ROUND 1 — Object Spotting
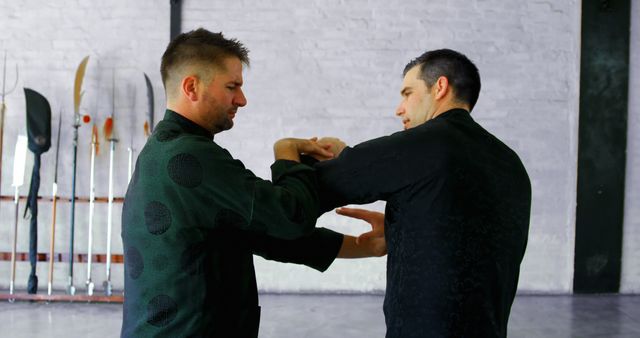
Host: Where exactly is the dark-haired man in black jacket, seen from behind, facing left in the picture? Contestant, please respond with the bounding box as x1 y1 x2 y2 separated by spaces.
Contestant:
315 49 531 338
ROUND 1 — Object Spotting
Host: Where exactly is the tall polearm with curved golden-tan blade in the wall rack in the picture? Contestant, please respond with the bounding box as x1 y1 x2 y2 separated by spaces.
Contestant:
67 56 89 295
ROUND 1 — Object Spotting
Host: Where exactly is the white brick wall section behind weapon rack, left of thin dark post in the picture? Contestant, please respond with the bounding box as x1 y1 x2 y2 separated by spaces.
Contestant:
0 0 169 292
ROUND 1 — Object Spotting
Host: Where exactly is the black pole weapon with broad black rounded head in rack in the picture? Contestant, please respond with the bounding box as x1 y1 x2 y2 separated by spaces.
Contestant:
24 88 51 294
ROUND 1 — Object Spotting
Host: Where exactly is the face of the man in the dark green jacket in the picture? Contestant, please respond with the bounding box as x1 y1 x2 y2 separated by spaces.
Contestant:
201 57 247 133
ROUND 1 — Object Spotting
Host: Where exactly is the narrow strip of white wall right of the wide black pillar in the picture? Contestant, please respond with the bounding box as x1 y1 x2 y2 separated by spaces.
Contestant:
620 0 640 293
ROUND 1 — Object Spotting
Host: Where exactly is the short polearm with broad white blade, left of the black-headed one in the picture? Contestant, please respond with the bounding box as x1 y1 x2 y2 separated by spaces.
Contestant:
9 135 28 295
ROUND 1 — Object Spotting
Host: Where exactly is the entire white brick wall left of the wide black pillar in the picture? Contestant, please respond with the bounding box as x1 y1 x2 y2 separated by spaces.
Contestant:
0 0 592 292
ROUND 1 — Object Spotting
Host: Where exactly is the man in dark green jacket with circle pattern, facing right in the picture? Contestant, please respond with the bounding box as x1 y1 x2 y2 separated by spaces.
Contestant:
121 29 386 337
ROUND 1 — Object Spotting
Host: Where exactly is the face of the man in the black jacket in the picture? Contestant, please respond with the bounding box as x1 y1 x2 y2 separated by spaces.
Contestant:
396 66 435 129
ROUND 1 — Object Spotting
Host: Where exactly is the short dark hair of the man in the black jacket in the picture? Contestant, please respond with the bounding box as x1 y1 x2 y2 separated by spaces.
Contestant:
402 49 480 110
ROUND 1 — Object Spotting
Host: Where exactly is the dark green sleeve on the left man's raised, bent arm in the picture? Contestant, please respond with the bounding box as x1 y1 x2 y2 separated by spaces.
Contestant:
178 137 318 239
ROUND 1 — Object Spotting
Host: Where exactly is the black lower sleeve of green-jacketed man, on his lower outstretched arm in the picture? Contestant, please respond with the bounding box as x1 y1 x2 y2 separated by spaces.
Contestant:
247 228 344 271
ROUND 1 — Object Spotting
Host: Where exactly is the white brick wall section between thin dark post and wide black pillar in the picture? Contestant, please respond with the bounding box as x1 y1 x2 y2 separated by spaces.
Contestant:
183 0 580 292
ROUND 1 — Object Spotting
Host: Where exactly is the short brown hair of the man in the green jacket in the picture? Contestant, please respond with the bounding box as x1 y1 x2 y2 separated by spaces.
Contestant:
160 28 249 95
